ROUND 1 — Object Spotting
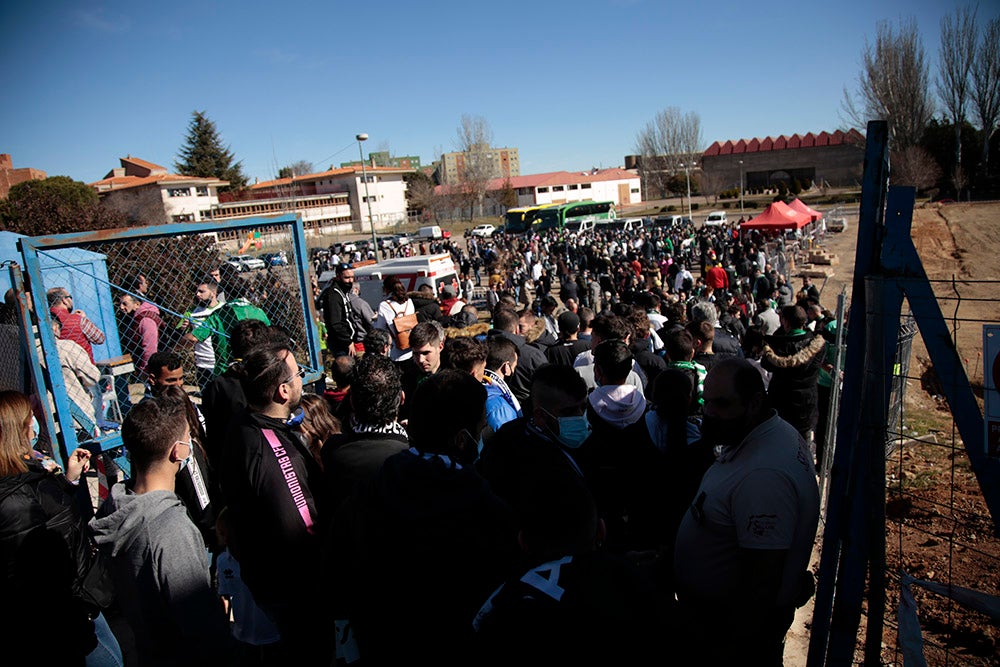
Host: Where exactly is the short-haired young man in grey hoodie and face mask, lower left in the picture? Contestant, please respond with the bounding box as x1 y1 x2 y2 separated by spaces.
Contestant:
90 398 232 665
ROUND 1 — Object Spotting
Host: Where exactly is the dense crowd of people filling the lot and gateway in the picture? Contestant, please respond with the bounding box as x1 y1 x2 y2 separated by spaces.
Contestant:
0 217 838 665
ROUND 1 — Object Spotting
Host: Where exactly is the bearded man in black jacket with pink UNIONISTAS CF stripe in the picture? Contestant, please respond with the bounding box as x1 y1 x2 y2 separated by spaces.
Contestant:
220 342 333 665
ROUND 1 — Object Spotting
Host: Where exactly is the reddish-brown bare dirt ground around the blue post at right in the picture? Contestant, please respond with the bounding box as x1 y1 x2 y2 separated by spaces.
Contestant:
786 203 1000 665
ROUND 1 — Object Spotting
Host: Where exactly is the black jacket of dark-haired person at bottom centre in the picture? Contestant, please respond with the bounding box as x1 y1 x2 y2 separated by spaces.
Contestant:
334 450 517 665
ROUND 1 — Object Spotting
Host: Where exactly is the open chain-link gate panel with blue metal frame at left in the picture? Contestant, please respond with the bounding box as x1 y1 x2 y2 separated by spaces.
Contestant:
14 216 322 468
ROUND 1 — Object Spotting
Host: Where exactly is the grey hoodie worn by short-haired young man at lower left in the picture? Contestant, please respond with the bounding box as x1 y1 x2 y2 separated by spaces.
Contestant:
90 483 230 665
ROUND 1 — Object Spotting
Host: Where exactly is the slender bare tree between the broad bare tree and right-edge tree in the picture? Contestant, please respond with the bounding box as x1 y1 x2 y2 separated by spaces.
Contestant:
937 7 976 170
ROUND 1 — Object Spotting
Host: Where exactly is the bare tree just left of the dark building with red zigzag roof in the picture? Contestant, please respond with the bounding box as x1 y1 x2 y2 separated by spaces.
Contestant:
635 107 702 199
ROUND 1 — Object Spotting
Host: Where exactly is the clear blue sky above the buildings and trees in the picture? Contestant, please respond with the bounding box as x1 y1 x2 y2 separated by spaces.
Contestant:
0 0 1000 182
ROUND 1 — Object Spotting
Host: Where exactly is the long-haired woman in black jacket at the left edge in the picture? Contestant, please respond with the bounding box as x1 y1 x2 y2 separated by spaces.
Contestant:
0 391 122 665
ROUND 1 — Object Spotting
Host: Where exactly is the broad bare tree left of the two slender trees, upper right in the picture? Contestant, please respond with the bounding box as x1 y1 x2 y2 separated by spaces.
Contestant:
843 18 934 150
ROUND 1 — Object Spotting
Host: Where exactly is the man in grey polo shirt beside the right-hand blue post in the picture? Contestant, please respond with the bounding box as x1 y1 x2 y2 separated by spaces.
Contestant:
674 358 819 665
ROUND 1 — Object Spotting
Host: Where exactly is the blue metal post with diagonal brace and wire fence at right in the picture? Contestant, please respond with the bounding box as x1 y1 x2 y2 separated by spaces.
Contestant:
809 121 1000 666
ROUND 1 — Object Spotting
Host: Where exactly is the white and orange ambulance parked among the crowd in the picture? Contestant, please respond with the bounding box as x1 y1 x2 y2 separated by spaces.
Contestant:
319 253 468 309
